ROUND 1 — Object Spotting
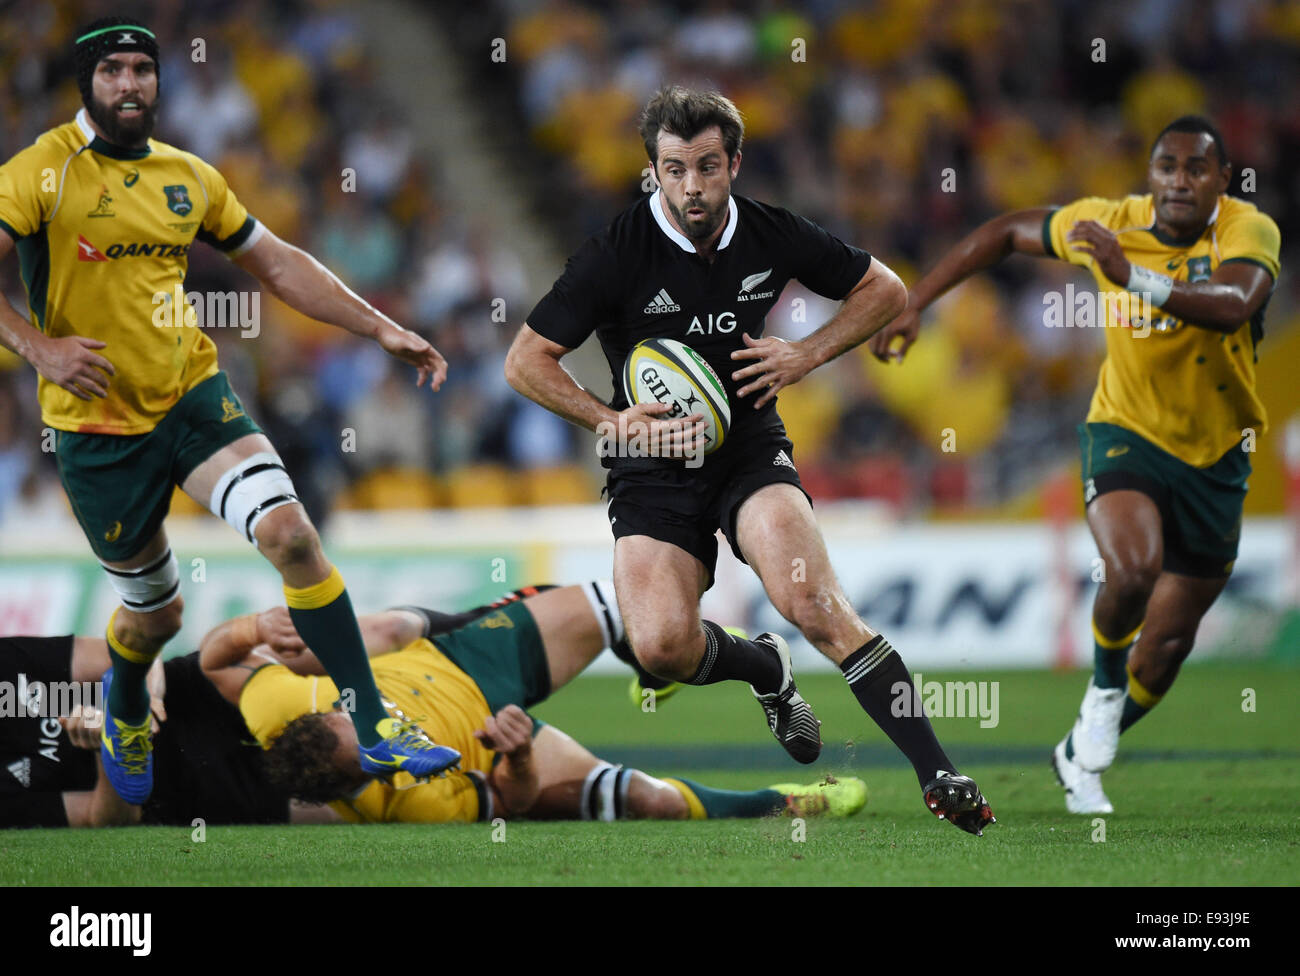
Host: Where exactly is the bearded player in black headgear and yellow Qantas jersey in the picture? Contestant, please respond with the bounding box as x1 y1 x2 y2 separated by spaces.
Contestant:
0 18 458 803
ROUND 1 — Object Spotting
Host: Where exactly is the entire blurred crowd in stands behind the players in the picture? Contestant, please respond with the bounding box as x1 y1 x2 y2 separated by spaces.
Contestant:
0 0 1300 535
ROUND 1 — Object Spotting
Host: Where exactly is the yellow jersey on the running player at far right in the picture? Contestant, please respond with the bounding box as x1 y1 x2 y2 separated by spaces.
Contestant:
1043 194 1282 468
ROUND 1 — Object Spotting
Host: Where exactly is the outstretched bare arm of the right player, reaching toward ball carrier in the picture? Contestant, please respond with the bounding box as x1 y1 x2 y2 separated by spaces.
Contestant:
868 207 1052 363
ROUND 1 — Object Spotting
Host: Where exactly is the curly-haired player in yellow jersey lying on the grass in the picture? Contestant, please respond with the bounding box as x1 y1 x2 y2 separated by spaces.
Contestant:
199 581 867 823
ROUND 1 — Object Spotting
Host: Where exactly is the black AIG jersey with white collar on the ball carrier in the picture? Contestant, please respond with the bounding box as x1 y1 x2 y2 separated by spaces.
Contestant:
527 191 871 462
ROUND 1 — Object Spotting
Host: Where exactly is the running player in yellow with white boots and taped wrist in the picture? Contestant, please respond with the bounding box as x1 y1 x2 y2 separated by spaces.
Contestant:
871 116 1281 814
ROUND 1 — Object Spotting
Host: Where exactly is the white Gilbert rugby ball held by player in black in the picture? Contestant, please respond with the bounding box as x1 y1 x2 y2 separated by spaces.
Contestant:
623 339 731 454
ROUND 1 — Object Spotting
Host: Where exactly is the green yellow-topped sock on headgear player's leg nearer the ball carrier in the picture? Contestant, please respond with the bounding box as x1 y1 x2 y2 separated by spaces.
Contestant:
285 569 389 746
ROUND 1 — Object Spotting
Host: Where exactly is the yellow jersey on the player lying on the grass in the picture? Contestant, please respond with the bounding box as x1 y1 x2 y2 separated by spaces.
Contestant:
239 638 495 824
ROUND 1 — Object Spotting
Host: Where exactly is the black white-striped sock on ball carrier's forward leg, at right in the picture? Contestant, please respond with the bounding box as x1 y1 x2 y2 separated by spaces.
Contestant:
840 634 957 786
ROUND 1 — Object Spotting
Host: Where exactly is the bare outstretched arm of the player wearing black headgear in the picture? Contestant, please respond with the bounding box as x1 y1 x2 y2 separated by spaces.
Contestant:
234 229 447 390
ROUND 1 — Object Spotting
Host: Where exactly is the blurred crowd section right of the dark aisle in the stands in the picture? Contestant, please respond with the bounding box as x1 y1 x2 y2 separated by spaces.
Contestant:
480 0 1300 509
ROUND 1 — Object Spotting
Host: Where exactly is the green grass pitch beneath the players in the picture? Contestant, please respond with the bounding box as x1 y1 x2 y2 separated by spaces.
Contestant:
0 664 1300 886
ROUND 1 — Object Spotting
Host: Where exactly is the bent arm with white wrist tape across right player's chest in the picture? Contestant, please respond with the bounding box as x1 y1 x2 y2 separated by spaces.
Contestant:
1066 221 1273 333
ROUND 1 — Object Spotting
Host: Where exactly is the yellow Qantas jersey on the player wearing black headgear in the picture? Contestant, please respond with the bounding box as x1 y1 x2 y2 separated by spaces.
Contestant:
0 109 261 434
